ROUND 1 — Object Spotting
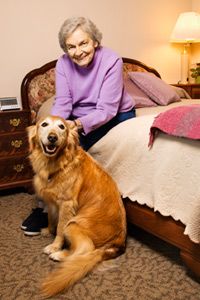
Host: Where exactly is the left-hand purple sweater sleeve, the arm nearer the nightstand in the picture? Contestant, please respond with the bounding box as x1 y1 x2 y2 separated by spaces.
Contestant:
51 60 72 119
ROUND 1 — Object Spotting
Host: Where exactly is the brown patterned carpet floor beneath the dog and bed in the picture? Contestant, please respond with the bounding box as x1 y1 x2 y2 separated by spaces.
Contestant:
0 192 200 300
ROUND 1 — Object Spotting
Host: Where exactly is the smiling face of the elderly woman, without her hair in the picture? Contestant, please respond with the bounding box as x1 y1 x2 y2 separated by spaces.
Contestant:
66 27 98 67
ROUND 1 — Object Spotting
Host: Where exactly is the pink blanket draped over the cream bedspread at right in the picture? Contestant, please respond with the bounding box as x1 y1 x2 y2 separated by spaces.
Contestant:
149 104 200 147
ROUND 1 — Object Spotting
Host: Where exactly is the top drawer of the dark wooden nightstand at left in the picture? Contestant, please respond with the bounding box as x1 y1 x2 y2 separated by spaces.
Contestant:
0 111 29 133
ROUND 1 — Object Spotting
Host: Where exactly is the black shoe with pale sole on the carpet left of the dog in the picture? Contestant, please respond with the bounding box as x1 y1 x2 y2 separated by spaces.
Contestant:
21 208 48 236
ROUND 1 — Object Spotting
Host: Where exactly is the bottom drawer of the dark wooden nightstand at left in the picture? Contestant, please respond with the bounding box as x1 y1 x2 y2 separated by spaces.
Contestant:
0 155 33 185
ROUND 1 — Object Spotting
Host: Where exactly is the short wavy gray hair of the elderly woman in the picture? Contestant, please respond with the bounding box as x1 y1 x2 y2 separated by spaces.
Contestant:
58 17 102 53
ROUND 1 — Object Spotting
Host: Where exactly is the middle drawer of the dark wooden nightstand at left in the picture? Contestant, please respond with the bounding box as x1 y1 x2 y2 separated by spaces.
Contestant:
0 132 28 157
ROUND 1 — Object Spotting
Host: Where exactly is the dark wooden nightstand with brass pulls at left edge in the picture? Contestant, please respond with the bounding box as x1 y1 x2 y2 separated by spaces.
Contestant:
0 109 33 190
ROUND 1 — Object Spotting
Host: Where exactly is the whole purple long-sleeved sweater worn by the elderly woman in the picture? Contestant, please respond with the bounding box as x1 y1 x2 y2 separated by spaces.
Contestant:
51 47 133 134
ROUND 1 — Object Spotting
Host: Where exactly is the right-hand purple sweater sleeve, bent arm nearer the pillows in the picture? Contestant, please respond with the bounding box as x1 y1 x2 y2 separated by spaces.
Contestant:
79 58 123 134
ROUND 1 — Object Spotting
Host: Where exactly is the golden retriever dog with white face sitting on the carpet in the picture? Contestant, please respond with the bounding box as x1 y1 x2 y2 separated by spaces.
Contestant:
27 116 126 297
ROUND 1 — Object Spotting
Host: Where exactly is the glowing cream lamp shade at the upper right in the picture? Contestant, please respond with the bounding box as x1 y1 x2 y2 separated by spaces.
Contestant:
170 12 200 43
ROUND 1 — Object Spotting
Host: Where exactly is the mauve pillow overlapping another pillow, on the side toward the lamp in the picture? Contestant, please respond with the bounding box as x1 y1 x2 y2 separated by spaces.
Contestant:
128 72 181 105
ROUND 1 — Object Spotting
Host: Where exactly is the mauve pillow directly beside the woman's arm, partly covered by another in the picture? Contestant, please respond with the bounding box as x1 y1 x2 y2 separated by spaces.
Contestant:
124 74 157 108
